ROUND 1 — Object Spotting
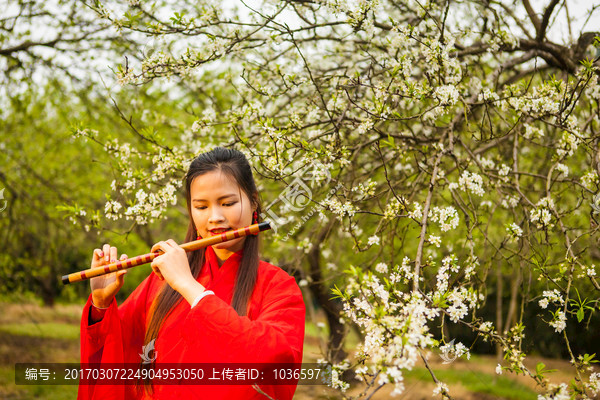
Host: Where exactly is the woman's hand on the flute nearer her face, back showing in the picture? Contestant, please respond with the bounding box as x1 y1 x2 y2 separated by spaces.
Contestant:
151 239 196 293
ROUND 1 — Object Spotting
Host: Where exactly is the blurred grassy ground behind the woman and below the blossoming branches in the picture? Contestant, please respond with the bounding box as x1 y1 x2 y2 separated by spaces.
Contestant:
0 303 592 400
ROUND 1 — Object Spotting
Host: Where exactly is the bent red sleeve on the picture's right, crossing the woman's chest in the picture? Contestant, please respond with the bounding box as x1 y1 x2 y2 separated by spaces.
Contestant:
183 270 305 399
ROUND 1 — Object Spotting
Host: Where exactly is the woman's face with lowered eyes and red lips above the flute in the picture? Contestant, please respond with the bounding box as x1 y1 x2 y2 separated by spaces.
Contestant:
190 170 255 260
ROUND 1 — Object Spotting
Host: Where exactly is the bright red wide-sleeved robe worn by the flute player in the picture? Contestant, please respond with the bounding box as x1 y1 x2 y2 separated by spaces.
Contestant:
77 247 305 400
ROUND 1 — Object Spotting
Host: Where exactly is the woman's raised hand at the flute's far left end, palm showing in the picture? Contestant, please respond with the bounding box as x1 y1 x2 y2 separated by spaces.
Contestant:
90 244 128 308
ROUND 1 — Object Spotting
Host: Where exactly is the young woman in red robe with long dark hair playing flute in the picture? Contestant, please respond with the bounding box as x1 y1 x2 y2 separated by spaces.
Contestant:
78 147 305 400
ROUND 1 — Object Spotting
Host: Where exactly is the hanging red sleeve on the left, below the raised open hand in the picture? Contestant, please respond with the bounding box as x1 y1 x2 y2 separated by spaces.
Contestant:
77 274 153 400
